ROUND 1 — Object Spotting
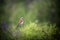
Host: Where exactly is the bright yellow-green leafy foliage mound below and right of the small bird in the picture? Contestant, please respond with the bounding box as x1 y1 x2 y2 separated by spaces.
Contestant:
20 22 56 40
